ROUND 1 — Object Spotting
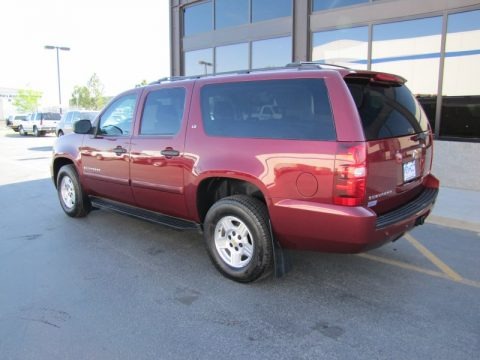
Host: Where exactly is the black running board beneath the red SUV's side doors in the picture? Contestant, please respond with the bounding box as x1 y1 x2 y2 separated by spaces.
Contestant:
90 196 202 232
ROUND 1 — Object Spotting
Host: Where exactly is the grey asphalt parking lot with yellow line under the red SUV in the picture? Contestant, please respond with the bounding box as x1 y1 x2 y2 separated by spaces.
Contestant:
0 124 480 360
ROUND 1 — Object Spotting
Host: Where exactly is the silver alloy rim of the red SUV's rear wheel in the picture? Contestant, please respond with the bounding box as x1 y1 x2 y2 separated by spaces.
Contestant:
215 216 255 269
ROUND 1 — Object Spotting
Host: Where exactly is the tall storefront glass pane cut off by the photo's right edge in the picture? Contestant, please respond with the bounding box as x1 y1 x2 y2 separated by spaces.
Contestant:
440 10 480 139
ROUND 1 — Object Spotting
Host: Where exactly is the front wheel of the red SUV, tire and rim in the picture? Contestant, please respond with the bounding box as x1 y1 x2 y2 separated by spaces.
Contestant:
57 165 91 217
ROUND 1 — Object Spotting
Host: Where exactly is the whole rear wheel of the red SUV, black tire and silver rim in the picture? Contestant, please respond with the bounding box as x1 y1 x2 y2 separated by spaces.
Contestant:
204 195 273 283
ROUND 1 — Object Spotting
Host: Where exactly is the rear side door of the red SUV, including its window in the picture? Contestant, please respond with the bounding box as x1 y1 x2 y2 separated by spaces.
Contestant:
130 87 190 217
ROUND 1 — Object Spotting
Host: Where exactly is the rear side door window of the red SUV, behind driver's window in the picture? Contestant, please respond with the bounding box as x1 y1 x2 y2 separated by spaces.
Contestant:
140 88 185 135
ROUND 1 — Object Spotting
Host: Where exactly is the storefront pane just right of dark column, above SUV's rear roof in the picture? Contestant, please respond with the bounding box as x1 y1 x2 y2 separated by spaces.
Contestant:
312 26 368 69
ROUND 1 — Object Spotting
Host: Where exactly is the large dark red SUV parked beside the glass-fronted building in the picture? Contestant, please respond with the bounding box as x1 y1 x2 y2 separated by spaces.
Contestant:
52 64 439 282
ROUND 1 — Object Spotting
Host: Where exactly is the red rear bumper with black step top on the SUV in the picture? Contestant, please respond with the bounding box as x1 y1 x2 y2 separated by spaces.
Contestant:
270 178 438 253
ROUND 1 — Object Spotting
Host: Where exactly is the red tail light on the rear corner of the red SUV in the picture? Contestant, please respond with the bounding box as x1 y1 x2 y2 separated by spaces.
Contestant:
333 143 367 206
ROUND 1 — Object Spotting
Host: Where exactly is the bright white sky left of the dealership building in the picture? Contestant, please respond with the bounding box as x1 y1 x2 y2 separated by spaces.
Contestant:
0 0 170 107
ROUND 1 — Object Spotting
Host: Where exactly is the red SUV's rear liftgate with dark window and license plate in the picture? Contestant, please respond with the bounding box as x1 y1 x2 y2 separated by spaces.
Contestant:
346 73 432 214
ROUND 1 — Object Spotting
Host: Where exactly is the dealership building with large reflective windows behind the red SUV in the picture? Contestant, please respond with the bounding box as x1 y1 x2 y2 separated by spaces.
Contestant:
170 0 480 190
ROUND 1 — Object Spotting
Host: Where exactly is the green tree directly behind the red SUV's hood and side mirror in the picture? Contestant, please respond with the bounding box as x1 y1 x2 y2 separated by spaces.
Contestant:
69 73 107 110
